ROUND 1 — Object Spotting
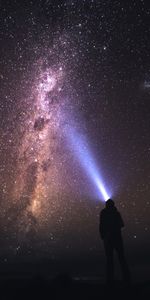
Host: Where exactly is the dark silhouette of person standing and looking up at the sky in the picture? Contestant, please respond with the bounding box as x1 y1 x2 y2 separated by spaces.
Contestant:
99 199 130 284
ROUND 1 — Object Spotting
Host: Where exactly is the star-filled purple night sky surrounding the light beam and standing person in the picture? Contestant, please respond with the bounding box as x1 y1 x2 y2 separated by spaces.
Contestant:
0 0 150 270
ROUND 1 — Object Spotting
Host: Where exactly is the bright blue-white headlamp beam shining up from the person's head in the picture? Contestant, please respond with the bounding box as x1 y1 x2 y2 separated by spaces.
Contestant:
67 127 110 201
